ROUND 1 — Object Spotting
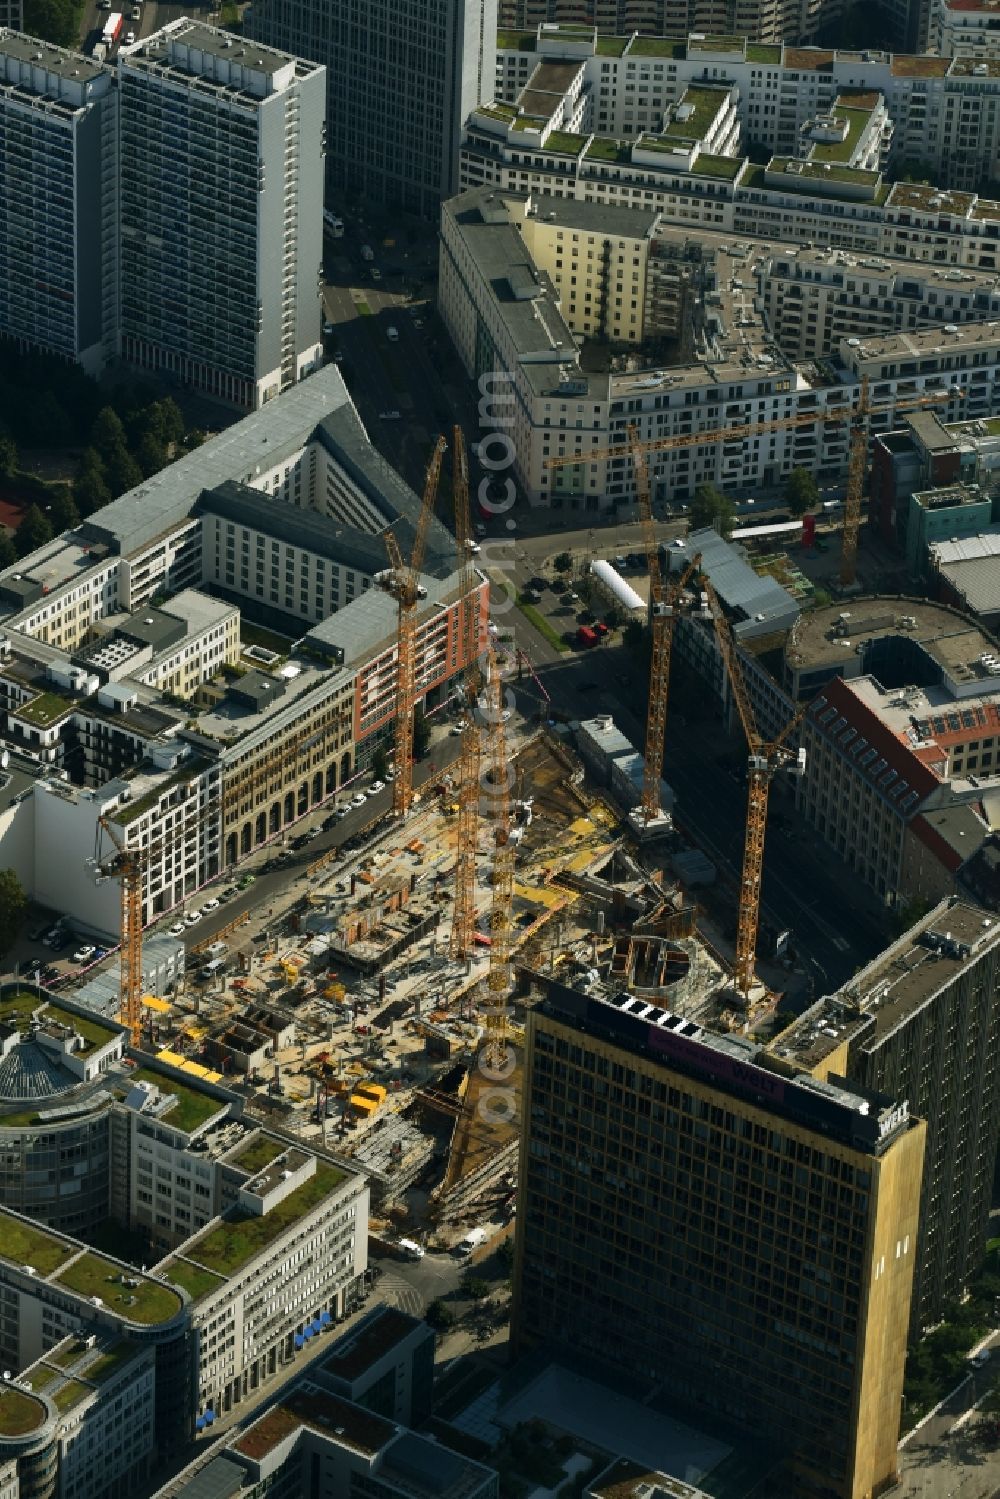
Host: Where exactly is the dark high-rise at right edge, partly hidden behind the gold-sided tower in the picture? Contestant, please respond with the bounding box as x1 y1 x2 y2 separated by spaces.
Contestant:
774 898 1000 1333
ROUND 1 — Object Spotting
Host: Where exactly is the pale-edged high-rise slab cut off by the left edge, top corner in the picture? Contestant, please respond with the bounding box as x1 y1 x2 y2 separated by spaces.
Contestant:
0 31 118 375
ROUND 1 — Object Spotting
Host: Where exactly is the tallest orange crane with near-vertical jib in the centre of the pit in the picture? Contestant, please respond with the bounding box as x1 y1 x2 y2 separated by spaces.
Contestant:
450 427 483 961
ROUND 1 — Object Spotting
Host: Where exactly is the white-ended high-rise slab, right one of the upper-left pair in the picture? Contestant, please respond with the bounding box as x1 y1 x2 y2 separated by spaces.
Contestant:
118 19 325 409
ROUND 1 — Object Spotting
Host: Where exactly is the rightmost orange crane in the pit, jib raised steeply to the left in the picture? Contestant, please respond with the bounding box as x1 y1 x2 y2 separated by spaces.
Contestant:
705 580 808 1009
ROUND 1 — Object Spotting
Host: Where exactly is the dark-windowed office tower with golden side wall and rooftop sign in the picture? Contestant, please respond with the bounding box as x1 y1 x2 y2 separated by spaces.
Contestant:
513 980 925 1499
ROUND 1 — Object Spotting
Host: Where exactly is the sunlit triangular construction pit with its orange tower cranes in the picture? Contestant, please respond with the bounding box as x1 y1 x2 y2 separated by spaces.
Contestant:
70 430 833 1249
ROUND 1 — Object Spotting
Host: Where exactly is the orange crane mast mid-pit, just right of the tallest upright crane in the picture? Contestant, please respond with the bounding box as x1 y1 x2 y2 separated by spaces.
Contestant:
483 646 516 1072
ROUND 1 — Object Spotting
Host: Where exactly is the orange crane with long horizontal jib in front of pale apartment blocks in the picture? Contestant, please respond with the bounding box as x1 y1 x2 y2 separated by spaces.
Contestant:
546 375 961 588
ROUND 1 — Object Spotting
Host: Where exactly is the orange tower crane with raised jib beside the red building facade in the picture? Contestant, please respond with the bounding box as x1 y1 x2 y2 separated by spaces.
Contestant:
375 438 447 817
